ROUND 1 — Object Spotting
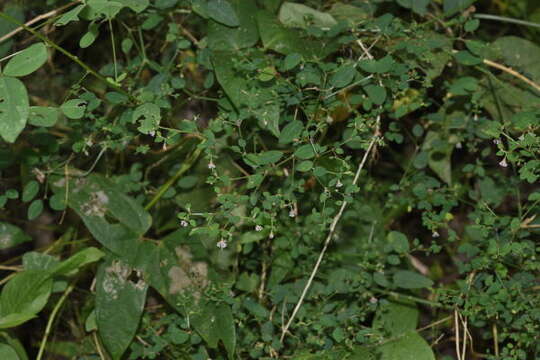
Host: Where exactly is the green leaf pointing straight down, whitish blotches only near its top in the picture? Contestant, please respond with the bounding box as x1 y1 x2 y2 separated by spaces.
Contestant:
95 257 148 360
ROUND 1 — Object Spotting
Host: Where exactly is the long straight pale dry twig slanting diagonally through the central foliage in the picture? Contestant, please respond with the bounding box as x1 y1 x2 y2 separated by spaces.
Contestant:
280 119 381 342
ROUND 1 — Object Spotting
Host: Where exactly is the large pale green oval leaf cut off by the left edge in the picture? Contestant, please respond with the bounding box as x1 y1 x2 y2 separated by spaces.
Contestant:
0 76 30 143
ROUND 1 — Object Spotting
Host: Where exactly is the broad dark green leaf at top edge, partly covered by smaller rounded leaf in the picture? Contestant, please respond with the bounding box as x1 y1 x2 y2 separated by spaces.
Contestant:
207 0 259 51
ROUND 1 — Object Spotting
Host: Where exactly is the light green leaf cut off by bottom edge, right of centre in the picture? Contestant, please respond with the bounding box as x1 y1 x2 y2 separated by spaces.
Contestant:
377 332 435 360
